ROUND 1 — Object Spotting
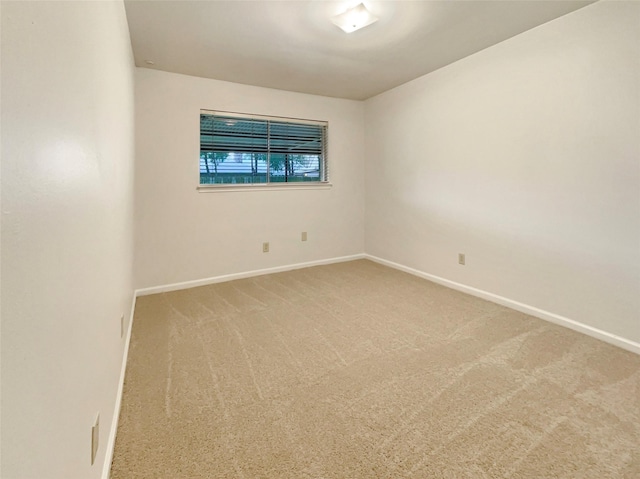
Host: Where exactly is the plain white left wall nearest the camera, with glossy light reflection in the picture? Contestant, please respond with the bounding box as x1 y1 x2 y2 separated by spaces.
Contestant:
1 2 134 479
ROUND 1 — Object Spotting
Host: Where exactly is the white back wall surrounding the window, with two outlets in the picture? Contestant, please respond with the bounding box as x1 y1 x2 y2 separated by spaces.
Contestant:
135 68 364 288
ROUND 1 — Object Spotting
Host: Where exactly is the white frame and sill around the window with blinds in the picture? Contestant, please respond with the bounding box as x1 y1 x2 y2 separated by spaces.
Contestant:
197 109 332 192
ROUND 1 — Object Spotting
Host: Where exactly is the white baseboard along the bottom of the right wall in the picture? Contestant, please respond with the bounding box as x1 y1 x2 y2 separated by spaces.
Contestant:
364 254 640 354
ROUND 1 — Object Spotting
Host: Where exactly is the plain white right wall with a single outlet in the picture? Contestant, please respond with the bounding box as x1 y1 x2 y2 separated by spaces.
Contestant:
365 2 640 342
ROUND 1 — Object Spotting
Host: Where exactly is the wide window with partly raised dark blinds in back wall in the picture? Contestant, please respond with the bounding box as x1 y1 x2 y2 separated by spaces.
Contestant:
200 110 328 186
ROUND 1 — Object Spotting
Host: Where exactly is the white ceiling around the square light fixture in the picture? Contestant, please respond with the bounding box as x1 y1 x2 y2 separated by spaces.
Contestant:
125 0 593 100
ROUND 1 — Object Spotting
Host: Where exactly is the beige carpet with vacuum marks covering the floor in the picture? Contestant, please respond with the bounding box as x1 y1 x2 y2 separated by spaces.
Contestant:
111 260 640 479
